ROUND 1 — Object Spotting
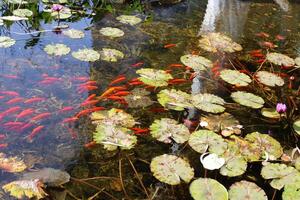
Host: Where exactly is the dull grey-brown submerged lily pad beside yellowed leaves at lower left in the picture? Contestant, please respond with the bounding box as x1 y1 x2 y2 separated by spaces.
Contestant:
22 168 70 187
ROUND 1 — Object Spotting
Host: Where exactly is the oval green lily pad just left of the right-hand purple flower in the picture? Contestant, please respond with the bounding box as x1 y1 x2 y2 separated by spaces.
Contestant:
231 91 265 109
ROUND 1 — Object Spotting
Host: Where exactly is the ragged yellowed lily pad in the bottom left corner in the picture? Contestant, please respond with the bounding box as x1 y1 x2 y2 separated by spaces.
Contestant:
2 179 47 199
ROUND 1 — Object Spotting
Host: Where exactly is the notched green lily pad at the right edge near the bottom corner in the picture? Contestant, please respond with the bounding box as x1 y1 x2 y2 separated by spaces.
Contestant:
261 163 300 190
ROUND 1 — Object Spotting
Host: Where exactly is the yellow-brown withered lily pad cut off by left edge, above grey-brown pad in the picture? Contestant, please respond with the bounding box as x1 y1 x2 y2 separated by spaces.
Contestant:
0 153 27 173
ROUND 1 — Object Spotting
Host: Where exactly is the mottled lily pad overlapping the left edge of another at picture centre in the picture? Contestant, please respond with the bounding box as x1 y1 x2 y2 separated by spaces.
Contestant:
157 89 194 111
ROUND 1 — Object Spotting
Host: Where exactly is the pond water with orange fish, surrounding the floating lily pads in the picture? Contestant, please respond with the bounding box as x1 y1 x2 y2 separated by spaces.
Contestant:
0 0 300 199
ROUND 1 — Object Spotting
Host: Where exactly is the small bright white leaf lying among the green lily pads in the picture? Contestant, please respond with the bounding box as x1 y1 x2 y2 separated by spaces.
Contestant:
200 153 225 170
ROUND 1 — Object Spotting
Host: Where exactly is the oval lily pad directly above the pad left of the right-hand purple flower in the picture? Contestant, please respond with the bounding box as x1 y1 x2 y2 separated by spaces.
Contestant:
256 71 284 87
